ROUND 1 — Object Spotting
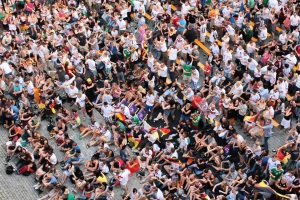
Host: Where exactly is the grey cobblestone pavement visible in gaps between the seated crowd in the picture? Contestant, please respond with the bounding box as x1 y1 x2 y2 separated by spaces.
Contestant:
0 41 286 200
